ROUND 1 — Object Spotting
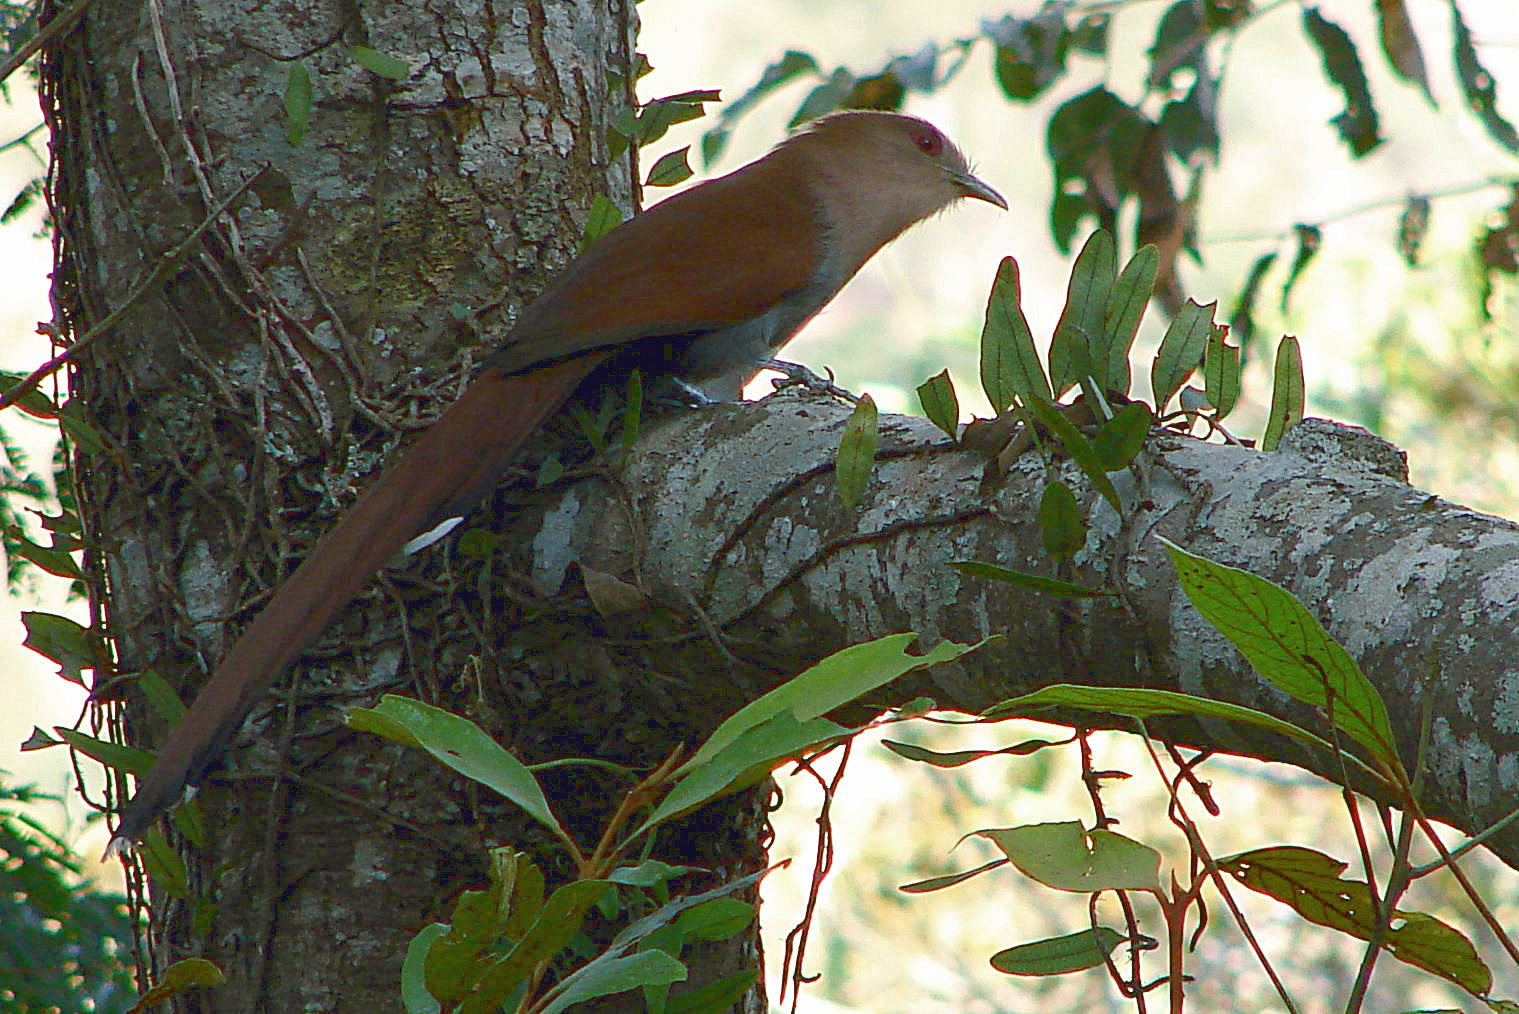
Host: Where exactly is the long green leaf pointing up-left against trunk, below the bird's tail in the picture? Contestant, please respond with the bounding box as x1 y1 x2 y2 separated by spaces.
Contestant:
343 694 568 839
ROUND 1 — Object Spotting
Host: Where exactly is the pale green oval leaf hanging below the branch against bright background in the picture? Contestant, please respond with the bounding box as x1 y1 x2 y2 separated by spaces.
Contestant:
974 820 1161 894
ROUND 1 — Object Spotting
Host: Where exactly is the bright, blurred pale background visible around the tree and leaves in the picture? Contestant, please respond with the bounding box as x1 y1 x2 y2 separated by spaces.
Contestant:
0 0 1519 1014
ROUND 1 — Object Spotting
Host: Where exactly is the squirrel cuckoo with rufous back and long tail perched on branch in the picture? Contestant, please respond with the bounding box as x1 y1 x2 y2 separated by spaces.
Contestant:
106 111 1007 856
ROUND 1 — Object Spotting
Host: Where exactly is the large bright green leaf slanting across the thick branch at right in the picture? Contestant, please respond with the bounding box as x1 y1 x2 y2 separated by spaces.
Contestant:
1162 539 1399 771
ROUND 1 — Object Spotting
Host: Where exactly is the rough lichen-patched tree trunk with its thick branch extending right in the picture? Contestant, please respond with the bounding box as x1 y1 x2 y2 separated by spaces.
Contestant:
43 0 1519 1012
